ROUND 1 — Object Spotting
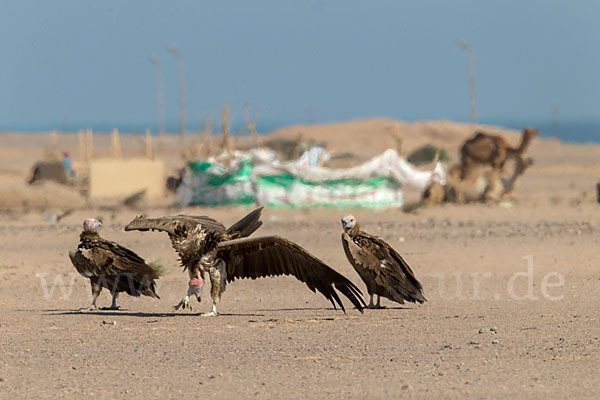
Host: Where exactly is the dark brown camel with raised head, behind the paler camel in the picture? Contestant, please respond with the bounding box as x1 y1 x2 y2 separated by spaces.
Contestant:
460 127 539 173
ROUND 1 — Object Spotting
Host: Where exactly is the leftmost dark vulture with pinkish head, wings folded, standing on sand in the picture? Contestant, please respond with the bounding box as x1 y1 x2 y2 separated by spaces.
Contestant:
69 218 159 310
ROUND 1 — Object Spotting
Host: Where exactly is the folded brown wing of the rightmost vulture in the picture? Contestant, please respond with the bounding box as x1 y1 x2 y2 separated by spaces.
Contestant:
344 231 427 303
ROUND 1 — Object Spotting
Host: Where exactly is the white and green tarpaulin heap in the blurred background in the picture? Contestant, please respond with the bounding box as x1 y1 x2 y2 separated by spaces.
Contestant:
178 149 445 207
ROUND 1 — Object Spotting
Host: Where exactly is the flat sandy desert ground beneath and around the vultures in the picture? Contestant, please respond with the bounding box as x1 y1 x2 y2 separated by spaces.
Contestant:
0 120 600 399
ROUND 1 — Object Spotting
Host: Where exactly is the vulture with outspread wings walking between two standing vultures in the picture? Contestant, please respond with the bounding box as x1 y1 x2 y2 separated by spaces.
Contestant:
125 208 365 316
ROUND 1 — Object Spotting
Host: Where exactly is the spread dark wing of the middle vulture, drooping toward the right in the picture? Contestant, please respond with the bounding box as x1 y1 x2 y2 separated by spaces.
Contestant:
217 236 365 312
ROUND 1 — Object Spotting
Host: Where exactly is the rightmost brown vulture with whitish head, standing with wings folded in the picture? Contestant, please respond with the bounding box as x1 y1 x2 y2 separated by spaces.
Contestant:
342 215 427 308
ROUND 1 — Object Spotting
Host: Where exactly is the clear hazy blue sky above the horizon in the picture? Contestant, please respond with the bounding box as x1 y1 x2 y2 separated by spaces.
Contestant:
0 0 600 130
